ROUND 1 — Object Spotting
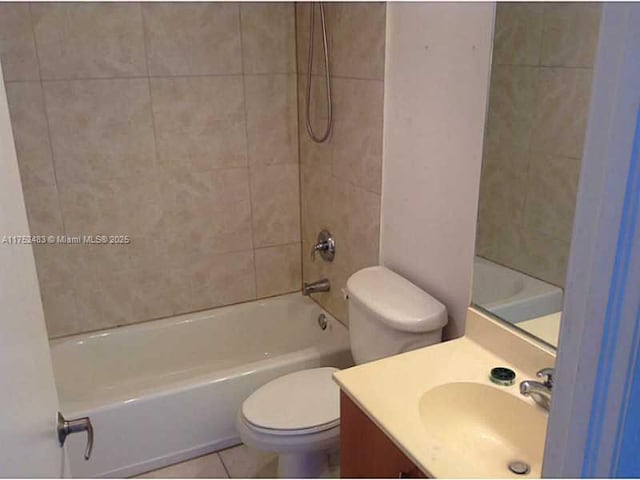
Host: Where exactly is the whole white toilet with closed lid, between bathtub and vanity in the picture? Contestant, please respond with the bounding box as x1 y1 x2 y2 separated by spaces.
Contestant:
236 266 447 478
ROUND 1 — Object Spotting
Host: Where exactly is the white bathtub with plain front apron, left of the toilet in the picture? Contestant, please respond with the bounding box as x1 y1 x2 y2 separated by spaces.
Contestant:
51 294 353 477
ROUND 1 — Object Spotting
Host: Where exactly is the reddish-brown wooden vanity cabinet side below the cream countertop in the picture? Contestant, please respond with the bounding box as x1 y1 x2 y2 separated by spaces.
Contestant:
340 391 427 478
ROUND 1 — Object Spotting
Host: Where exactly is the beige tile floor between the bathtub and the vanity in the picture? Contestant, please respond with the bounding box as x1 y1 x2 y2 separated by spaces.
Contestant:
137 445 340 478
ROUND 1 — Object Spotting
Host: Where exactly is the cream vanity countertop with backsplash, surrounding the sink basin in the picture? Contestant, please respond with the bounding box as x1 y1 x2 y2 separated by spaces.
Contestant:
334 312 555 478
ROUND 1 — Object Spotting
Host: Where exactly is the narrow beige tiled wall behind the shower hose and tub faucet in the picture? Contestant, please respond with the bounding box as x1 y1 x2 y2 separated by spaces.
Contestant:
296 2 386 322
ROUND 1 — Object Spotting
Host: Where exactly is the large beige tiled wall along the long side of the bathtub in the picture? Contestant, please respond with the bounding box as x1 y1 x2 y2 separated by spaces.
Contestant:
0 3 300 337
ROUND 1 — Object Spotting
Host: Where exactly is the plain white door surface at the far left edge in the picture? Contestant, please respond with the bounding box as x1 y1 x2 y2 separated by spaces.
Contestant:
0 62 65 477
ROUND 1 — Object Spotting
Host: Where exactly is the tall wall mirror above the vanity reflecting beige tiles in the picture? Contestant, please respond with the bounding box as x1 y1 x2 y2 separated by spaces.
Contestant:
472 3 600 346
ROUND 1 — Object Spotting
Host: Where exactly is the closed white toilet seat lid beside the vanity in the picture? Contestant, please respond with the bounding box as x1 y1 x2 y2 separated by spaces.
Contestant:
242 367 340 431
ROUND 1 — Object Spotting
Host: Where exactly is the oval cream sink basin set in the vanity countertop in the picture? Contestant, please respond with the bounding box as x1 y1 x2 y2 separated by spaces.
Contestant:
419 383 547 478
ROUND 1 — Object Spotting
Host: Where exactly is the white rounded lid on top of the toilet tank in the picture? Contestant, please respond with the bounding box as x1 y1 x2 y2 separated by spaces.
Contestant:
347 266 447 332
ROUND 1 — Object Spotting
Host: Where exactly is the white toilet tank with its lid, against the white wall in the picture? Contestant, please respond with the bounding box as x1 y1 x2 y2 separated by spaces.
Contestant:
347 266 447 364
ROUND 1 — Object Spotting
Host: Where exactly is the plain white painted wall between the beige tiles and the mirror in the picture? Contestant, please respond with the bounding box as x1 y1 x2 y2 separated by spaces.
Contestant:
380 3 495 338
